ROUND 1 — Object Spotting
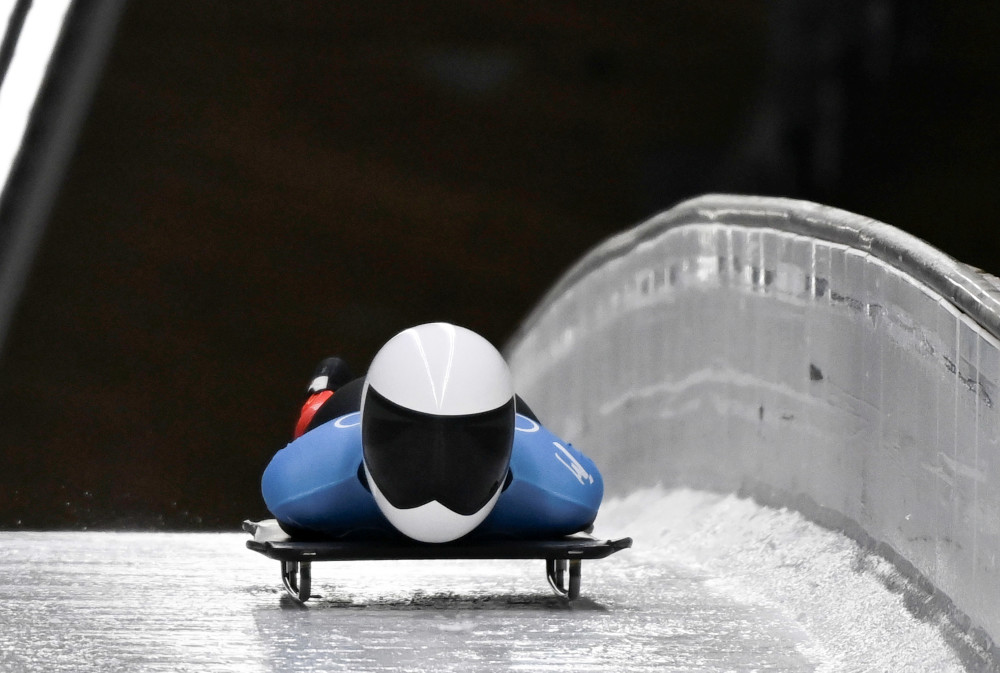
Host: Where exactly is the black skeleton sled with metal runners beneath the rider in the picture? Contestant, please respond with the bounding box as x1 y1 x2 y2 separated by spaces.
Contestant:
243 521 632 603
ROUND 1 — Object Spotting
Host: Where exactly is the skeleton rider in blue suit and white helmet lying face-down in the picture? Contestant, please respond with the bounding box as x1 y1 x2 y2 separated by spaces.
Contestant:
261 323 604 543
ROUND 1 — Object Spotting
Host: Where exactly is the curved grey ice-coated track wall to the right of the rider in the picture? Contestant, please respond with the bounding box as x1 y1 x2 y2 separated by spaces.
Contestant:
508 196 1000 649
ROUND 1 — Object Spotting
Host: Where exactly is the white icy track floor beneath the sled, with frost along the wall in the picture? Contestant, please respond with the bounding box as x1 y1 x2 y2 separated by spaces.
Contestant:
0 490 962 673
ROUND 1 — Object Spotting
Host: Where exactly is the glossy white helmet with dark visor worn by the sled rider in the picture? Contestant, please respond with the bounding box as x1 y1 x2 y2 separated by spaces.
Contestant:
361 323 514 542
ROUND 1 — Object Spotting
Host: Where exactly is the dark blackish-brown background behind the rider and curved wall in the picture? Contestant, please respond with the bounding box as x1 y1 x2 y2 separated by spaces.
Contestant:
0 0 1000 528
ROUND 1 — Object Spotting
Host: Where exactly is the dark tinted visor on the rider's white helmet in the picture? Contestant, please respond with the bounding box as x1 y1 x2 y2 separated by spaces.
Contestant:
361 386 514 516
